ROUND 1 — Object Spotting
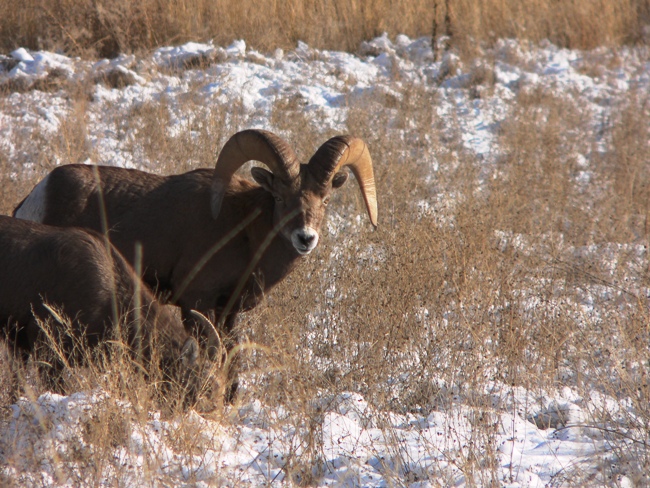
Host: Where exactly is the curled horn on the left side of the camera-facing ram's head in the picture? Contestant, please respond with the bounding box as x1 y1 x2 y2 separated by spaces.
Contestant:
210 129 300 219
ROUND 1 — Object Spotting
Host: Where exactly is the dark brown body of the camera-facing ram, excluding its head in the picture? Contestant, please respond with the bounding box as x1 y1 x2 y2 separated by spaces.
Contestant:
19 165 300 330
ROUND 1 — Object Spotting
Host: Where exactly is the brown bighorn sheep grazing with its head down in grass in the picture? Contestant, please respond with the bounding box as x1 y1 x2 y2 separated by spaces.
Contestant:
0 216 216 404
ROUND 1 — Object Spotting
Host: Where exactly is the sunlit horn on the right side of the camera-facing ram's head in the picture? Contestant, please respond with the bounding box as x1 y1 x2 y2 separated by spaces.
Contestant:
308 136 377 227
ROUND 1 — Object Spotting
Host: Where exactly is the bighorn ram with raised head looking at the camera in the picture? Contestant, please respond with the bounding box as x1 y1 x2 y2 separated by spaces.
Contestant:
14 129 377 391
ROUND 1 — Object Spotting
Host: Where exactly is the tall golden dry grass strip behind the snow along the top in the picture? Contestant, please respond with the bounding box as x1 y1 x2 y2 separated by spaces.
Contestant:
0 0 650 57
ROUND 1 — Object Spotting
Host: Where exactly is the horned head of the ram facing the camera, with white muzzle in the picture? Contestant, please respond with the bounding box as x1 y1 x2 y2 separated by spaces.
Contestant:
211 130 377 254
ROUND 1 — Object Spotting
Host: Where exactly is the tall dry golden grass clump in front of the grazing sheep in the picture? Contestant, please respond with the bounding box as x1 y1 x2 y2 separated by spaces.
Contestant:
0 307 223 416
